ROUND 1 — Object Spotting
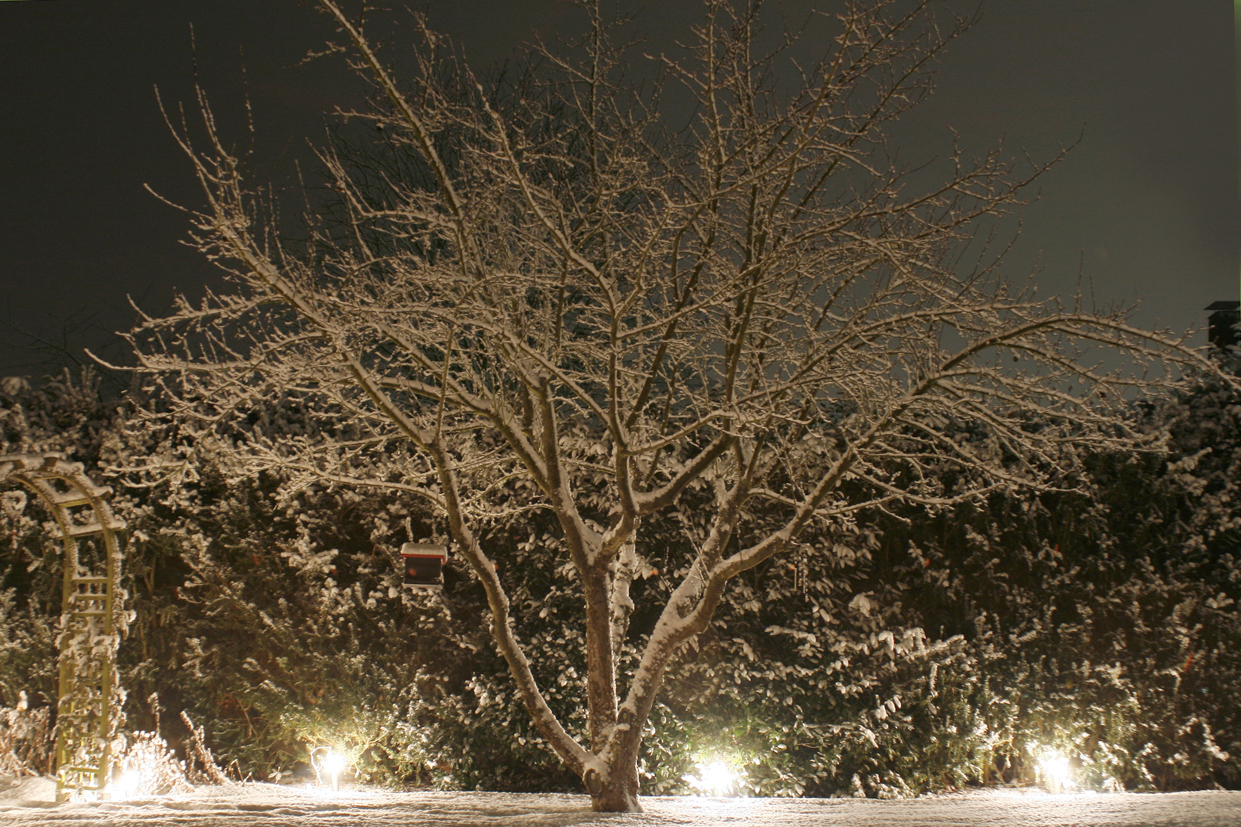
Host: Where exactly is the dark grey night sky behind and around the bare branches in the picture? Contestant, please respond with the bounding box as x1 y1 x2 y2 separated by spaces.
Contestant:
0 0 1241 375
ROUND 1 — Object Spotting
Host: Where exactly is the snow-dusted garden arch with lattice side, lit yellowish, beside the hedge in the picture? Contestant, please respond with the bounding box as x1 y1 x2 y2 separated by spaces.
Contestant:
0 454 127 801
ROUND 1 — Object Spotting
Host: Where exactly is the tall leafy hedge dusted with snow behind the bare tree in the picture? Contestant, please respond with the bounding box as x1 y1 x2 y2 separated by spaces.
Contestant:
0 367 1241 796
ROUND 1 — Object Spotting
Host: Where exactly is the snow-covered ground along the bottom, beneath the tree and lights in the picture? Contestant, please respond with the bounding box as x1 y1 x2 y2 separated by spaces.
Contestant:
0 777 1241 827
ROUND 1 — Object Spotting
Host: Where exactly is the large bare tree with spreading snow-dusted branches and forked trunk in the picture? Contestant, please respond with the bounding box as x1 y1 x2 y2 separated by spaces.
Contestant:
111 0 1226 811
